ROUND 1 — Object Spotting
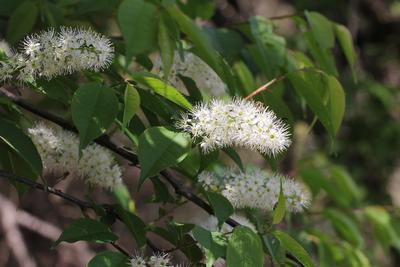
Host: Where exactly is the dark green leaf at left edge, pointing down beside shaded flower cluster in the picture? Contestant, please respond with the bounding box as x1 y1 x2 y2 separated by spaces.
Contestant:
0 118 43 176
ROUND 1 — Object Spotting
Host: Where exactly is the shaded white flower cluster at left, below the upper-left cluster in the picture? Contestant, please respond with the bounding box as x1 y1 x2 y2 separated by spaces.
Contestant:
28 123 122 190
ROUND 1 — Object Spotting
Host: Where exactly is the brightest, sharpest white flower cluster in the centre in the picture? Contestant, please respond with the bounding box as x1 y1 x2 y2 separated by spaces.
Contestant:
177 98 290 155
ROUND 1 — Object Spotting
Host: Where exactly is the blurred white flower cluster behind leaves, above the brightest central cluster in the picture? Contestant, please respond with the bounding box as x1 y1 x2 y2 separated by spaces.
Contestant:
153 51 226 96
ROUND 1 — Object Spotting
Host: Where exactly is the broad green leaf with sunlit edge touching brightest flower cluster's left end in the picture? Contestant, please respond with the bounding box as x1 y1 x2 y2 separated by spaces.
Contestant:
138 127 191 185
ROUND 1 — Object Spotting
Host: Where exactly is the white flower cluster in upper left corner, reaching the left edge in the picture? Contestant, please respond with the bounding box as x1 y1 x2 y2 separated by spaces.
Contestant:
0 27 114 82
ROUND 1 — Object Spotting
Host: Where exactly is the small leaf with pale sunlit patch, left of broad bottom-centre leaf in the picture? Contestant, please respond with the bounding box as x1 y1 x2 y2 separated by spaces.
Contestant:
192 225 226 259
